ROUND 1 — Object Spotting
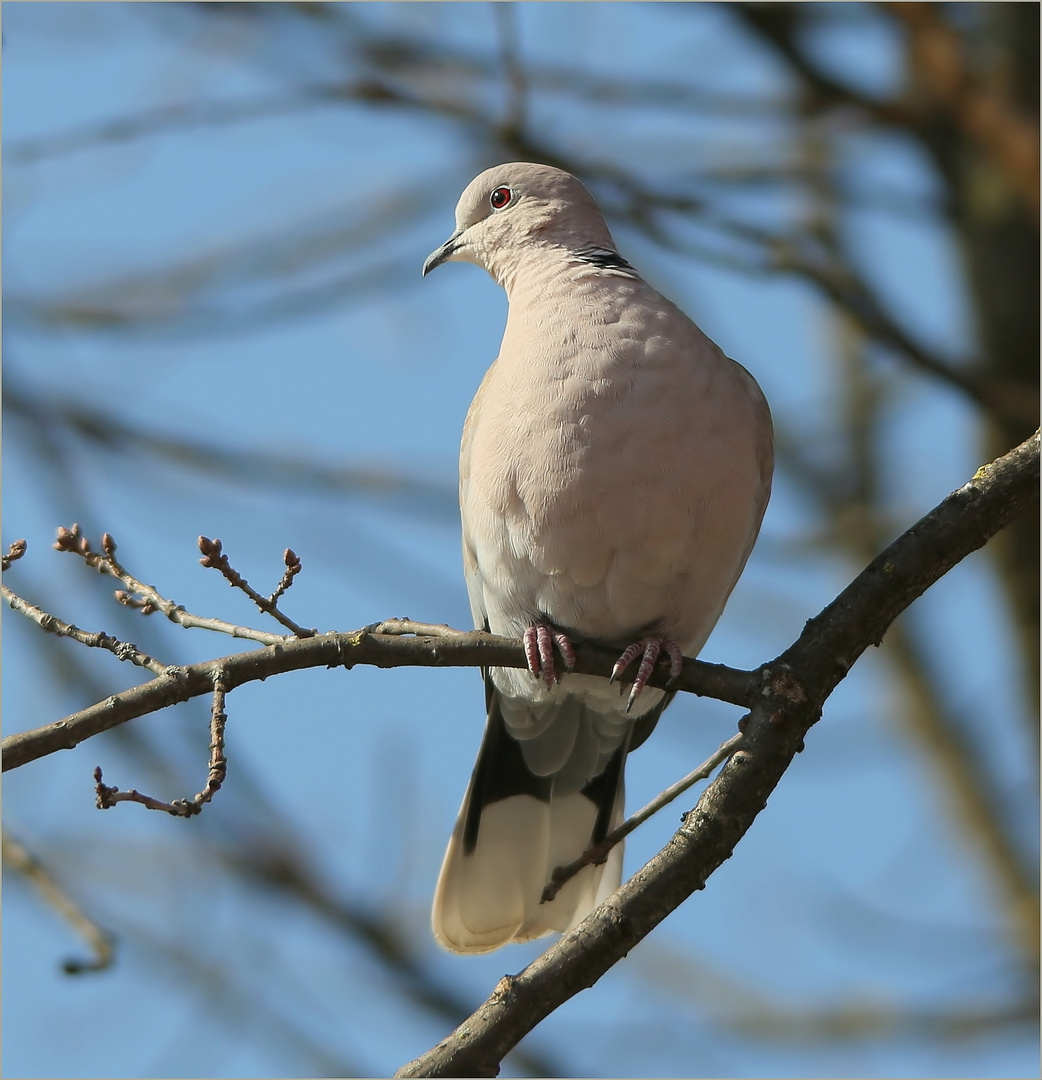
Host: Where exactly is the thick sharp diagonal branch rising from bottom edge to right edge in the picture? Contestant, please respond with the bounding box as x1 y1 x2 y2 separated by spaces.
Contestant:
396 432 1039 1077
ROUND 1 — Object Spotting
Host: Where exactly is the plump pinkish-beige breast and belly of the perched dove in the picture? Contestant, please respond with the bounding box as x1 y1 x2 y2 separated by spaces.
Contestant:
460 283 762 646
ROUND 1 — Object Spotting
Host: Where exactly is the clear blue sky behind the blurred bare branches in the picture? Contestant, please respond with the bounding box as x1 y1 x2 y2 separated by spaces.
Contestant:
3 3 1038 1077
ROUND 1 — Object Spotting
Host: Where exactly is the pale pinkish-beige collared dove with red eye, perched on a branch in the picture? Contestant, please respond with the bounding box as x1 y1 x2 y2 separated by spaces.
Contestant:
423 163 773 953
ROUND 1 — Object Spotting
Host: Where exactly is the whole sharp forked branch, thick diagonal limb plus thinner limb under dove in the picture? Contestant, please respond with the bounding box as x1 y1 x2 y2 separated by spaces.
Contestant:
2 432 1039 1076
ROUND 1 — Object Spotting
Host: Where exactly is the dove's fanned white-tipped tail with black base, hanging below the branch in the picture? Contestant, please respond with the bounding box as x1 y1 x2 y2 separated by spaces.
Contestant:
431 683 630 953
